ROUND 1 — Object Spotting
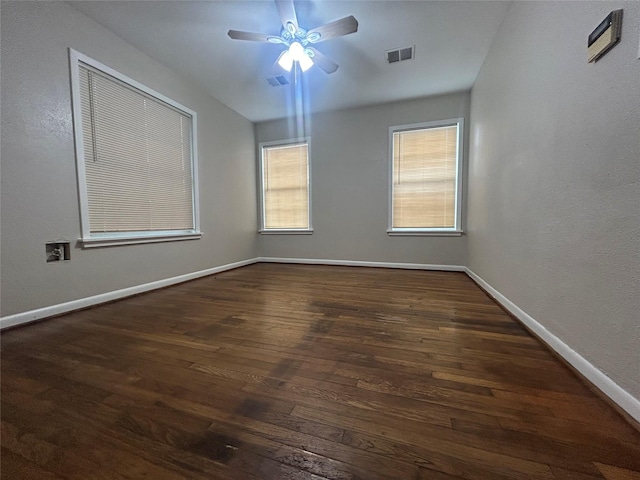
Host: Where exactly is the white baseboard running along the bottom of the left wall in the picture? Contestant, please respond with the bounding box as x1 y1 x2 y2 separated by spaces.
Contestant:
0 258 260 330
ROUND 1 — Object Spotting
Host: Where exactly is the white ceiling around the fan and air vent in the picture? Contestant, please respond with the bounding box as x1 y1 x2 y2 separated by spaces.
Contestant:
68 0 509 122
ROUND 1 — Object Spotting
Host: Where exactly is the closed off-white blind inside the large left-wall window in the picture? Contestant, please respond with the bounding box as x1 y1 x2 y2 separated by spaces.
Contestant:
79 64 195 234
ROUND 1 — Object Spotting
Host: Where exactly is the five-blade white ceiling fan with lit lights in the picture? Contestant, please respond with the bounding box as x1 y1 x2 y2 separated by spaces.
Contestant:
228 0 358 73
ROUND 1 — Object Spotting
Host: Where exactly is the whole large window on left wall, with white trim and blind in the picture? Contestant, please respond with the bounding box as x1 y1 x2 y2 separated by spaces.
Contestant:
70 50 201 247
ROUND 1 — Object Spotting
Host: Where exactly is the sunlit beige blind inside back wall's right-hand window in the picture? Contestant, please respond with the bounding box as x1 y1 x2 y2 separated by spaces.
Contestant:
392 125 458 228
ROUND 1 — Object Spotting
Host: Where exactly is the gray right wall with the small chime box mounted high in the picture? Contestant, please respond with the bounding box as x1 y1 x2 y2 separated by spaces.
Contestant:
468 2 640 398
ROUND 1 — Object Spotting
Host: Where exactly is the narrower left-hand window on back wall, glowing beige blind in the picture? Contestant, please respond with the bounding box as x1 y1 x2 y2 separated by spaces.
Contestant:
260 139 312 233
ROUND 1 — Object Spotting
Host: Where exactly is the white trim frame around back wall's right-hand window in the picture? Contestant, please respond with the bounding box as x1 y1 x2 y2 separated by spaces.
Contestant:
387 117 464 237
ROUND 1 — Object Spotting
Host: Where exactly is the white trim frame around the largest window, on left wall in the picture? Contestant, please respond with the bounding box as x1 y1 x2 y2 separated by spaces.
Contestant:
69 48 202 248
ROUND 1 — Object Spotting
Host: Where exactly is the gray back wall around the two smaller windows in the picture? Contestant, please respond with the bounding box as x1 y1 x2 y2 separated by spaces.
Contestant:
256 93 469 265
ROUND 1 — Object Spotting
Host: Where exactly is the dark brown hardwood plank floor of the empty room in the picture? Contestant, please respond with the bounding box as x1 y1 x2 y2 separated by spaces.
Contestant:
1 264 640 480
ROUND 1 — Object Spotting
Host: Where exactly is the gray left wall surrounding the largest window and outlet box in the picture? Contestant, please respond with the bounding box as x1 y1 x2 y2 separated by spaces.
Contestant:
1 2 257 316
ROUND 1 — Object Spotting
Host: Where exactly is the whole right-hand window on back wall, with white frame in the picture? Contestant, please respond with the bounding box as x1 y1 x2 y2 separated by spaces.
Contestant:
388 119 463 235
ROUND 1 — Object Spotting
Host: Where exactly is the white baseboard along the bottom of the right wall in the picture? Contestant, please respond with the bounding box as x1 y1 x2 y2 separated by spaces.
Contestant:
465 268 640 422
